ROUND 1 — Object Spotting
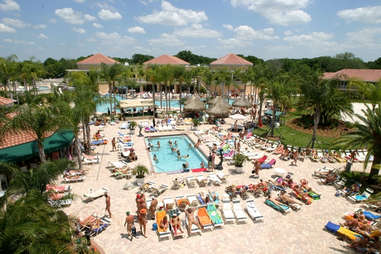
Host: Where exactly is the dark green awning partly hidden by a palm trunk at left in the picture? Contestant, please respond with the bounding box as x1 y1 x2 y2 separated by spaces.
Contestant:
0 131 74 162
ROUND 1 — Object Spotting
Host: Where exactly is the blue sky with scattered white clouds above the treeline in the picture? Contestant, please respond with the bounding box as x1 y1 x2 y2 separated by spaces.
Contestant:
0 0 381 61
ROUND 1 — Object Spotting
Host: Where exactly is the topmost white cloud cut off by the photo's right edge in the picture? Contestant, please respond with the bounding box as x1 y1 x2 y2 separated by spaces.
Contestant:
337 6 381 24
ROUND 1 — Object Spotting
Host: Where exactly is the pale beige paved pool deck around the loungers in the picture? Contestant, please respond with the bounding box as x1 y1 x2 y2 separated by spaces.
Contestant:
64 121 372 254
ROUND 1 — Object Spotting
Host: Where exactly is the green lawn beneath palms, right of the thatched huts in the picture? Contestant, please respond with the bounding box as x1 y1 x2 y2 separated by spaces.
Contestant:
254 113 336 149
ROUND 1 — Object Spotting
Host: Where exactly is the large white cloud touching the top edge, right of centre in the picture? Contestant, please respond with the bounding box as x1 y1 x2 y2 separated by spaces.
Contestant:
230 0 311 26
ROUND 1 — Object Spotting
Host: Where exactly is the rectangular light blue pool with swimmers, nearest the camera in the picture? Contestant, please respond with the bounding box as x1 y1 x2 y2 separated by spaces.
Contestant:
145 135 208 173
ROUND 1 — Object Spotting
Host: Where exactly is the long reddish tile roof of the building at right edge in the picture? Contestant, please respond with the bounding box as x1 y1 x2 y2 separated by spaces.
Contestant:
323 69 381 82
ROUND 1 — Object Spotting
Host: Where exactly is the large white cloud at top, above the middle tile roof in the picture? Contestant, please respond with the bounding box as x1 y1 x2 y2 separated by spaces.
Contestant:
138 0 208 26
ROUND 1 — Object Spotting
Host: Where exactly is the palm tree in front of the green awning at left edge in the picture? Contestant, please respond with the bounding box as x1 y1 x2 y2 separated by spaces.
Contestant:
0 104 62 162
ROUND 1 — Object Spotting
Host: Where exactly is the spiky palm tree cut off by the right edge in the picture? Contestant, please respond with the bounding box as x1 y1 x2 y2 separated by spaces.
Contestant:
338 103 381 181
